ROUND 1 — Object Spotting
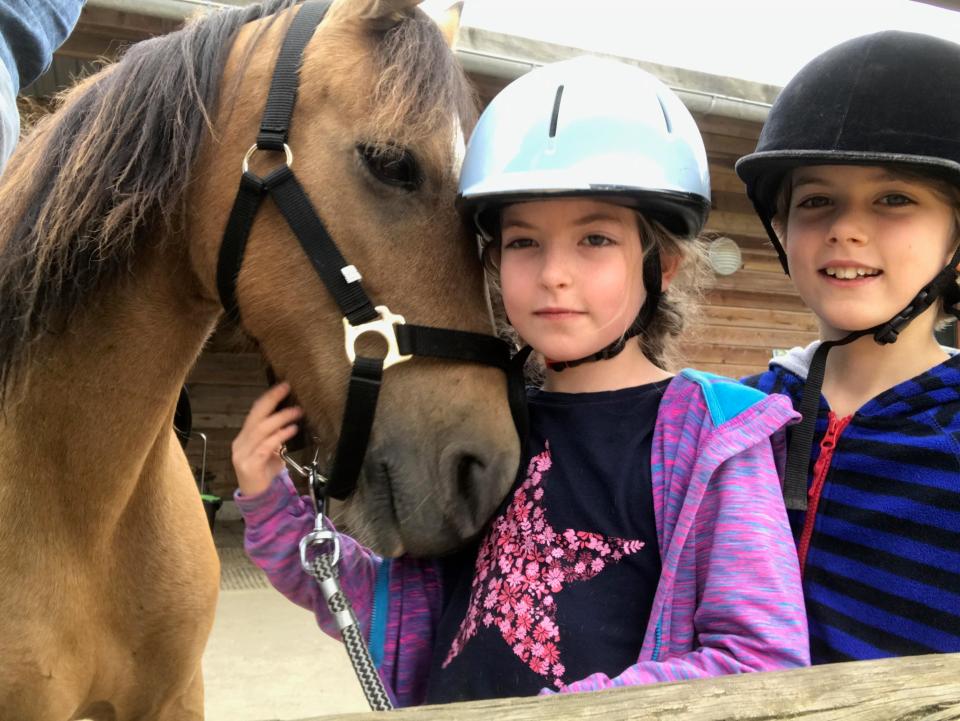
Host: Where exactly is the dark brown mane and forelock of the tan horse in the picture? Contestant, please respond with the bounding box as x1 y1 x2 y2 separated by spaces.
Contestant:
0 0 476 404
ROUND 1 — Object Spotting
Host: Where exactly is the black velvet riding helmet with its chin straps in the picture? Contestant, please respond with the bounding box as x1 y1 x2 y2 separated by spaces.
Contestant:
736 31 960 510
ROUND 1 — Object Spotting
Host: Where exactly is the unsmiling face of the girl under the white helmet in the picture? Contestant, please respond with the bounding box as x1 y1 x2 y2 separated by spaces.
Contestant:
500 198 646 361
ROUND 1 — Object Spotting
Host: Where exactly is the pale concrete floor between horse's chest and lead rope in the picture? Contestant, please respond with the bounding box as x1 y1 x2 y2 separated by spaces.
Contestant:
203 504 369 721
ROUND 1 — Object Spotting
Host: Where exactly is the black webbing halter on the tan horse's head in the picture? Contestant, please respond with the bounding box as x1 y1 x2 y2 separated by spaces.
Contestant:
217 1 526 499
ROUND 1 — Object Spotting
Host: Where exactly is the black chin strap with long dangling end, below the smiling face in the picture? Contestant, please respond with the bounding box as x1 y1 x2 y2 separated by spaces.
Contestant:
783 247 960 511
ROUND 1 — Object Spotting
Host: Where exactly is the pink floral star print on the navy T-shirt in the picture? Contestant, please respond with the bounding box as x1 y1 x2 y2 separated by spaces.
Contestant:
443 444 644 688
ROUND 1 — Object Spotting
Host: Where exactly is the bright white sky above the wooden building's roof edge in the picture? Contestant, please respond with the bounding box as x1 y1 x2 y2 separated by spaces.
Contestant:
421 0 960 85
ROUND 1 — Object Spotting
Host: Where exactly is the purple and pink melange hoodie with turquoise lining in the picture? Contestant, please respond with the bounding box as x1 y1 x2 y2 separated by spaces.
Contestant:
237 370 809 706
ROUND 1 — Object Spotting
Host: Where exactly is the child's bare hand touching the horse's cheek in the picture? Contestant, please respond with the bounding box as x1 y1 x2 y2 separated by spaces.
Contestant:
232 383 303 496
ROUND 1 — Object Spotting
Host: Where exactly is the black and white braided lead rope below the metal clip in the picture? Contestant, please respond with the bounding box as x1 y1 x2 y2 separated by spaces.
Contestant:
310 553 393 711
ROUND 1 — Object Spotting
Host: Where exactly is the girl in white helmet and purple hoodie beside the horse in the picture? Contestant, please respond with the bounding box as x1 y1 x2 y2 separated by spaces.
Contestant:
234 54 808 705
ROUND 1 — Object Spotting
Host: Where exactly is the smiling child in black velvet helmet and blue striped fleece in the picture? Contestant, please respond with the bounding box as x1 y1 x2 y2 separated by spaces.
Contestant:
737 31 960 663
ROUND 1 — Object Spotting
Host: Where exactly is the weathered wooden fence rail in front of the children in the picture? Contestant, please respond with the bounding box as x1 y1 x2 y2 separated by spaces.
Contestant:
305 654 960 721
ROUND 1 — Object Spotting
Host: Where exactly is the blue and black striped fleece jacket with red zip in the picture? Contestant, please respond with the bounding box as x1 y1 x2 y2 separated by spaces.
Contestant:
744 343 960 663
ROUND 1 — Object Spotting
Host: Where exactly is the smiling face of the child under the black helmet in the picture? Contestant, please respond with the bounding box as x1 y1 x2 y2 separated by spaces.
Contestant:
785 165 956 340
